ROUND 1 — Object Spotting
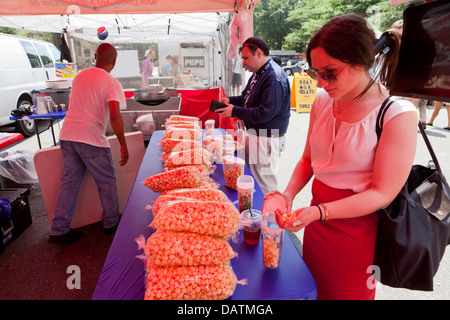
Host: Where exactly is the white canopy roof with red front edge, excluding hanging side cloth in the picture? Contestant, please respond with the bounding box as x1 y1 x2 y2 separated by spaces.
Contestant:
0 0 259 42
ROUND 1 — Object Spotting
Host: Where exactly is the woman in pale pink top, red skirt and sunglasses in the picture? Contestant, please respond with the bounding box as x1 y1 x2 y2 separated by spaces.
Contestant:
266 14 418 299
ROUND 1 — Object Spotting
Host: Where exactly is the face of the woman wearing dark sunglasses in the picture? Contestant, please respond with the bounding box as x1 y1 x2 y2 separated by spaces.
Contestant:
311 47 367 98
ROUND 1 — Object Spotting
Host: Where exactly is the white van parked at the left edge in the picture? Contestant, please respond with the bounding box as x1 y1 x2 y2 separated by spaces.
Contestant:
0 33 61 136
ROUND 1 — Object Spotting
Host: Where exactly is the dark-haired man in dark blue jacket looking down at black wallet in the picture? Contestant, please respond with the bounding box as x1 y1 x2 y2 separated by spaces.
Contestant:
216 37 291 193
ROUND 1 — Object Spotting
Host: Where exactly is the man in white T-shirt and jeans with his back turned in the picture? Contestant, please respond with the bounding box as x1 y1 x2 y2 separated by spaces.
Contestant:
49 43 128 243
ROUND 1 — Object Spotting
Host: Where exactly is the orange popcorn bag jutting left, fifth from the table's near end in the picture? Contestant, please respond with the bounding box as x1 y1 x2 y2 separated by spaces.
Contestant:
144 166 205 192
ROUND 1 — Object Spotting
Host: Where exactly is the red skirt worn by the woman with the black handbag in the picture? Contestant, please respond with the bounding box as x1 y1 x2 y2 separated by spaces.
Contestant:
303 179 378 300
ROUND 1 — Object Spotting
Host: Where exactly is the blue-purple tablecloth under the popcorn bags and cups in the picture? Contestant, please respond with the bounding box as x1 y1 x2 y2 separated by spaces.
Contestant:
92 131 317 300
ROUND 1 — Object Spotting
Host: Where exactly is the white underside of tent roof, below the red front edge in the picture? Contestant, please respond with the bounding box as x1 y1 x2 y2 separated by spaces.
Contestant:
0 13 230 43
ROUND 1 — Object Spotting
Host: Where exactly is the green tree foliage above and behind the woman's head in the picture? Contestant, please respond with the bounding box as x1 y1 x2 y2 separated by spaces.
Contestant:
254 0 418 52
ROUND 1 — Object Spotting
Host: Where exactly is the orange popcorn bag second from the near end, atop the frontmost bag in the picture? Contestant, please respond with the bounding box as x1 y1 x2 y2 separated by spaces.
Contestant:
144 230 236 266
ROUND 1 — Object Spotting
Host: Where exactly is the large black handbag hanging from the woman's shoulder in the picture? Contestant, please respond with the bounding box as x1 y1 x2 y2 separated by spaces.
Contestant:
374 98 450 291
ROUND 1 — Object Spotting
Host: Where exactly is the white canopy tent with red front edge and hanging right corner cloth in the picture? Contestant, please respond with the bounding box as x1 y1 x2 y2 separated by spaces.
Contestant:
0 0 260 90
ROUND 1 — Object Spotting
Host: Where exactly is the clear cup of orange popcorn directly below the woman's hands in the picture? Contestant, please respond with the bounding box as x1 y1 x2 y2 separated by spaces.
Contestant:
261 212 284 269
